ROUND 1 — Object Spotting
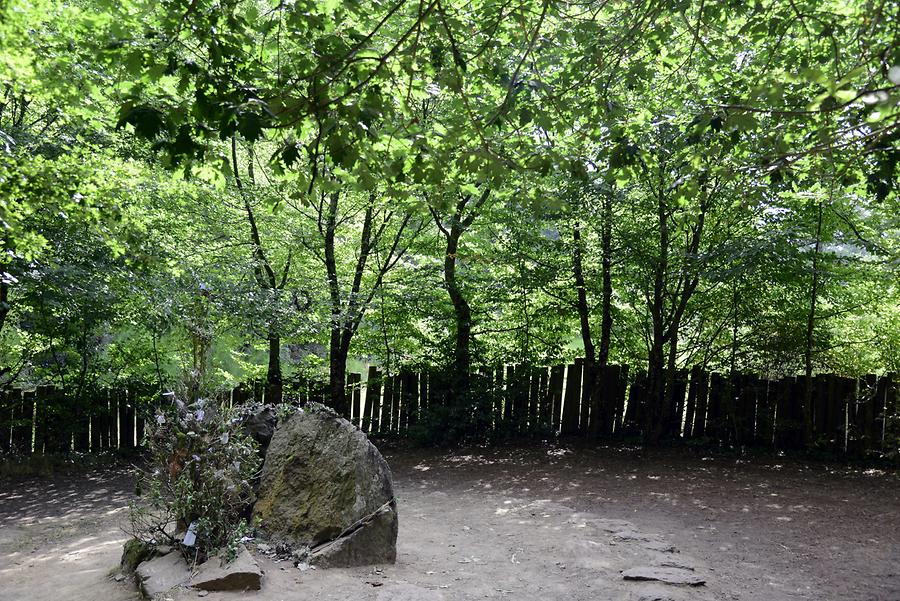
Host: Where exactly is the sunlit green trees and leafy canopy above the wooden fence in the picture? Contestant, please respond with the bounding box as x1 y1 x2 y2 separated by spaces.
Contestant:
0 0 900 439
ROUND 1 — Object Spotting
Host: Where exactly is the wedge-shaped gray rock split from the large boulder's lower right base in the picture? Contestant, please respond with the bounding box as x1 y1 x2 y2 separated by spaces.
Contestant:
309 505 397 568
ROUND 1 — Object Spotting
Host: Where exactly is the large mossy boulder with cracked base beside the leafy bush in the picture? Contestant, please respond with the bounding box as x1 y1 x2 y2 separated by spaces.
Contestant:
253 404 397 567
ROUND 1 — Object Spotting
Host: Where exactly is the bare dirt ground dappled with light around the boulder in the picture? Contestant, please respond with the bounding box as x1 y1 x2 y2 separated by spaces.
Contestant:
0 447 900 601
